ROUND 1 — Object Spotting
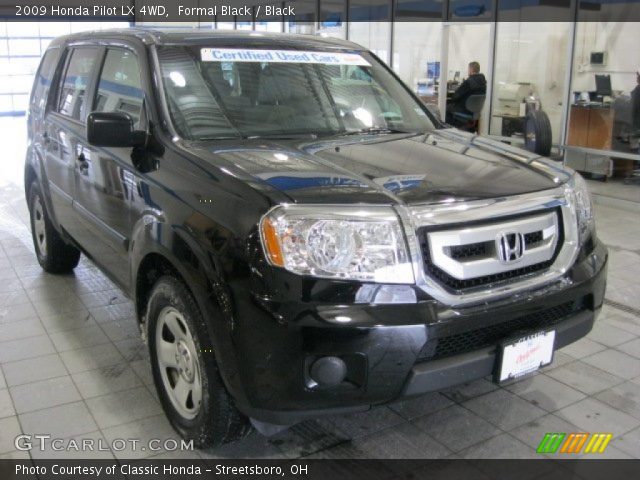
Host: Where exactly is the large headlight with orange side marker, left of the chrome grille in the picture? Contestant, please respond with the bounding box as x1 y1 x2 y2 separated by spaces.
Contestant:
260 205 414 283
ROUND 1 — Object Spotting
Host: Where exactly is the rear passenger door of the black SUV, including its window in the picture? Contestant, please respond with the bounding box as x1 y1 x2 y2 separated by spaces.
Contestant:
41 47 101 230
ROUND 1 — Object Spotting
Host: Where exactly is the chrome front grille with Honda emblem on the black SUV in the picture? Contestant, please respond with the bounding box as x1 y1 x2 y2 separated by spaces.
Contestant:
397 185 579 307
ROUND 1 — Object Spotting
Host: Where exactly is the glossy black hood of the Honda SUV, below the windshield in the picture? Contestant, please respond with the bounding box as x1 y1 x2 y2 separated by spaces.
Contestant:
190 129 570 204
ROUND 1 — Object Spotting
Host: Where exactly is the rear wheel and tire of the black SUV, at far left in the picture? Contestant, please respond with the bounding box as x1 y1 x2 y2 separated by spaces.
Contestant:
29 180 80 273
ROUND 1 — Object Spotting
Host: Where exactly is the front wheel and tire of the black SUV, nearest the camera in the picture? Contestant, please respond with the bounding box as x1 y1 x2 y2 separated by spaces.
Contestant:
147 275 250 448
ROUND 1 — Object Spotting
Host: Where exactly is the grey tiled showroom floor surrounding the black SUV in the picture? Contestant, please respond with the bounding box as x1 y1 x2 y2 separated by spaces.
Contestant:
0 119 640 459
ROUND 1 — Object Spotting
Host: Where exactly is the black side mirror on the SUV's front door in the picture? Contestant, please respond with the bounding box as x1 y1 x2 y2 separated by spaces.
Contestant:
87 112 147 148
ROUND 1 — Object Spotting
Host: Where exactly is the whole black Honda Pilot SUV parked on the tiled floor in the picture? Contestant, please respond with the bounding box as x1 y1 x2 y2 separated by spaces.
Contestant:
25 28 607 446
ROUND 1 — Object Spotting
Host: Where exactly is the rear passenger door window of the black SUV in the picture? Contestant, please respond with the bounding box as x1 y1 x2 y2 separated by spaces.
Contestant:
58 48 98 120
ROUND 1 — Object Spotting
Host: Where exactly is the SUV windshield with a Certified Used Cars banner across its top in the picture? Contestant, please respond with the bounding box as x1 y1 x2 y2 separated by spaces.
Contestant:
158 46 434 140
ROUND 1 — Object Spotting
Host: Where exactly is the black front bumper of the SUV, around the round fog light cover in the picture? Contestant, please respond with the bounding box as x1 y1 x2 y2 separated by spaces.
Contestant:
231 239 607 425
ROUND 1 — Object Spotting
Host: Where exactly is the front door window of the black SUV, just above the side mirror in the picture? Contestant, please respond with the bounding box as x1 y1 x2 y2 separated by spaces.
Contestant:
93 49 144 128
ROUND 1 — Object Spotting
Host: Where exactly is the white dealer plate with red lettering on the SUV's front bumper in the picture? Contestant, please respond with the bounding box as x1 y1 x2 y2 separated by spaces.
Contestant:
496 330 556 382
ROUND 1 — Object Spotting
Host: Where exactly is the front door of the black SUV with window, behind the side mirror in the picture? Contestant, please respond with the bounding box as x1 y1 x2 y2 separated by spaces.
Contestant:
74 47 146 287
